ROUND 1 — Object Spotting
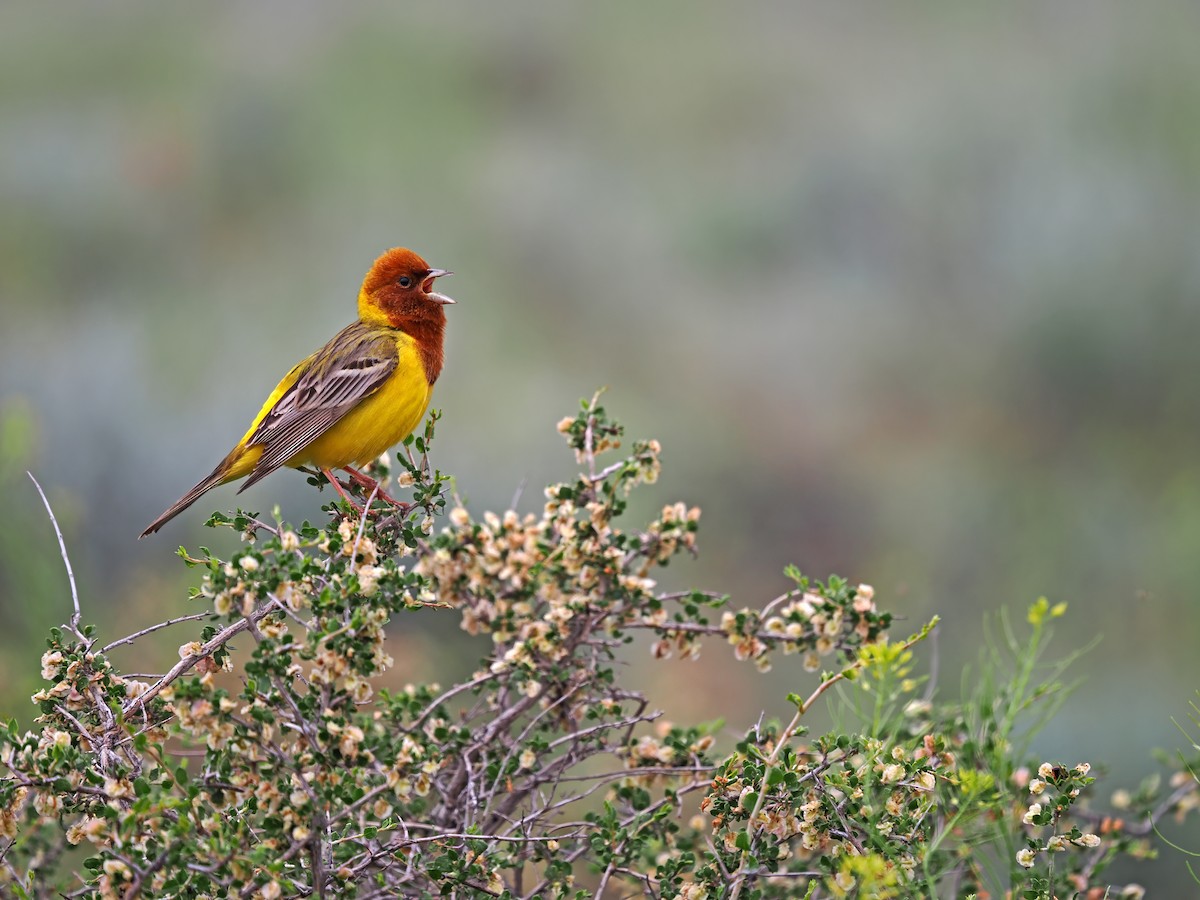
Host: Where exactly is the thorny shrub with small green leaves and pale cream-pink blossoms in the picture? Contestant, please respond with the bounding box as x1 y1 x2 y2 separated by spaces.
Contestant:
0 397 1196 900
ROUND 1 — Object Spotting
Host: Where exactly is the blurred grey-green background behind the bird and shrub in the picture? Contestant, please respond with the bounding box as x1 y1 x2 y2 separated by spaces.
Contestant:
0 0 1200 895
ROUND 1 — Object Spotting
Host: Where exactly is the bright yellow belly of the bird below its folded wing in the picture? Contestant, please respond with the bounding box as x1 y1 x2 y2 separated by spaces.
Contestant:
287 350 433 469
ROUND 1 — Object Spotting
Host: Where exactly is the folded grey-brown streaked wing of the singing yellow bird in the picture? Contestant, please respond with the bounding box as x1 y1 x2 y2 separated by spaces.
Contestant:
239 323 400 493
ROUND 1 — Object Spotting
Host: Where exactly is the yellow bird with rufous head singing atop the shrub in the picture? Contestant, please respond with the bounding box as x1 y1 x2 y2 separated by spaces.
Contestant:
139 247 455 540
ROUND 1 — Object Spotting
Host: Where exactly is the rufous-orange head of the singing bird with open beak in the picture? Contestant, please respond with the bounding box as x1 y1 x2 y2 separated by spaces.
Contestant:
359 247 454 331
